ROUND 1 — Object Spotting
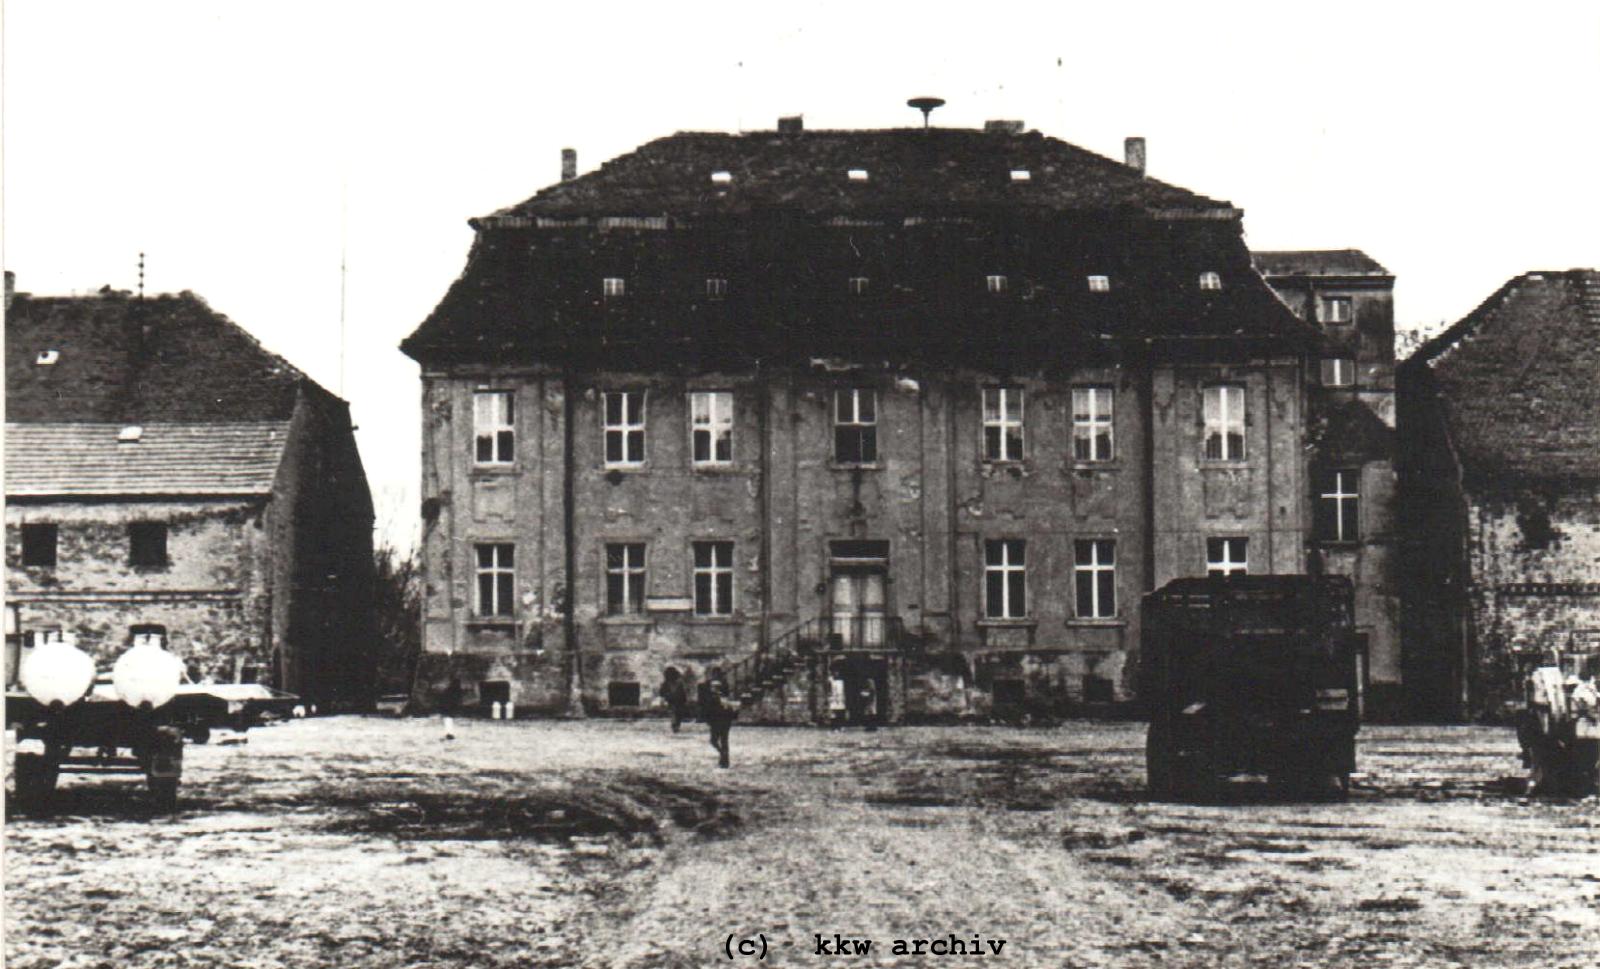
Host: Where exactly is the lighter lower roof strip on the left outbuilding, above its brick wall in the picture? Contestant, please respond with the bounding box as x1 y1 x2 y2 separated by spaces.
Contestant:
5 421 290 497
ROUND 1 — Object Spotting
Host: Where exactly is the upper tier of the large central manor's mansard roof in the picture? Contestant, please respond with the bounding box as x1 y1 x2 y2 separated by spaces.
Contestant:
491 128 1230 217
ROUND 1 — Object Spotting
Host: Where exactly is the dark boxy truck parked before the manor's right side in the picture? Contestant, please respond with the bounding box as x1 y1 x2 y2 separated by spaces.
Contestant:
1139 576 1360 798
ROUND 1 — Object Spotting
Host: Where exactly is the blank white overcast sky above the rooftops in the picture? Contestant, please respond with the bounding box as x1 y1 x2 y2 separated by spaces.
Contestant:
3 0 1600 544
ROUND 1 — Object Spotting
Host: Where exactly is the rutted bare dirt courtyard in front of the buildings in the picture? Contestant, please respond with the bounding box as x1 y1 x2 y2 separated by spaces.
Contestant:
5 718 1600 969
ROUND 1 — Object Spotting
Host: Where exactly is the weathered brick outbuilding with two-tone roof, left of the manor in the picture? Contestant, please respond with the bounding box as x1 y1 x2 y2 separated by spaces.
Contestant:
5 273 373 705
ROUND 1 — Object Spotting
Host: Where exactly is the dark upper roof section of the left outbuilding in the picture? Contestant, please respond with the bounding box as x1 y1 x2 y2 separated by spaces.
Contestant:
5 293 312 424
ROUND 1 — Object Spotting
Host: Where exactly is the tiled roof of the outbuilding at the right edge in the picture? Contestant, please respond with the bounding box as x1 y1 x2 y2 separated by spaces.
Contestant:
1408 269 1600 483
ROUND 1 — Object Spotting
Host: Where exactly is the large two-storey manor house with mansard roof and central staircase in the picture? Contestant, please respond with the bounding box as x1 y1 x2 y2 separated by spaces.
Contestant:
402 118 1344 723
